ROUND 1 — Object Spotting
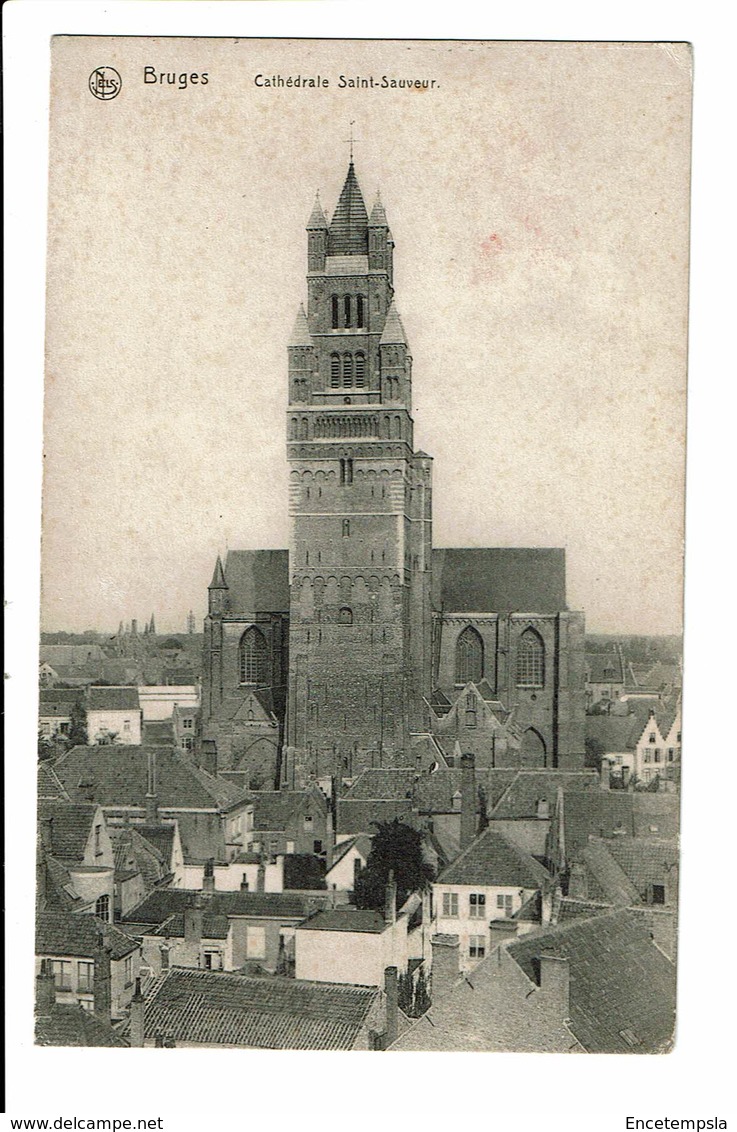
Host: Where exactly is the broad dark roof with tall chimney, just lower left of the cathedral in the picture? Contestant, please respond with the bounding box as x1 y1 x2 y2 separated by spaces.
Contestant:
53 745 240 809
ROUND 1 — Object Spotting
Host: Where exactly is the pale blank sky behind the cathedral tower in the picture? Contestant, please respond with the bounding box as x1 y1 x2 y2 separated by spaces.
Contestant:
42 37 691 634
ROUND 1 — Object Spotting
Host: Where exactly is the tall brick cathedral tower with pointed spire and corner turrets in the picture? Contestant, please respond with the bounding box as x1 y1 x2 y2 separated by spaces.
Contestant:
282 162 432 786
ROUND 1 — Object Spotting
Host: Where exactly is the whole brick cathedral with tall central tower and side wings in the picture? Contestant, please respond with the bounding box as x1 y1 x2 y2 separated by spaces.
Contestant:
199 160 585 789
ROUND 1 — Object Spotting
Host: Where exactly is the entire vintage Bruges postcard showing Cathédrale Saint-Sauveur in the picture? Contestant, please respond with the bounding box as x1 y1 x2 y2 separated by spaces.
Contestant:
35 35 692 1056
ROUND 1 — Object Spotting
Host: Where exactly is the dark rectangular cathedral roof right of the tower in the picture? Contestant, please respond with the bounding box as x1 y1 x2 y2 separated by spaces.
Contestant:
432 547 567 614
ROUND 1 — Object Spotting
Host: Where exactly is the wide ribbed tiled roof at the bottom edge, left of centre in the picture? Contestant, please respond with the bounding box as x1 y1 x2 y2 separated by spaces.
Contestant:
139 968 380 1049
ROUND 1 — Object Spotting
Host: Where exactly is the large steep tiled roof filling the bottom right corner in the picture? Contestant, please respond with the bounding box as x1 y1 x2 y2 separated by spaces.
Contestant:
507 909 676 1053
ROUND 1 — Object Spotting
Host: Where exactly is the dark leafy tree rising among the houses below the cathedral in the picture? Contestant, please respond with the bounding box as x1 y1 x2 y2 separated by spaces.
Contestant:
355 817 435 911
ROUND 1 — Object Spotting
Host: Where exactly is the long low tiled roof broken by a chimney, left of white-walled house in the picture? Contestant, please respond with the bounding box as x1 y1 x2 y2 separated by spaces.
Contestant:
123 889 314 924
